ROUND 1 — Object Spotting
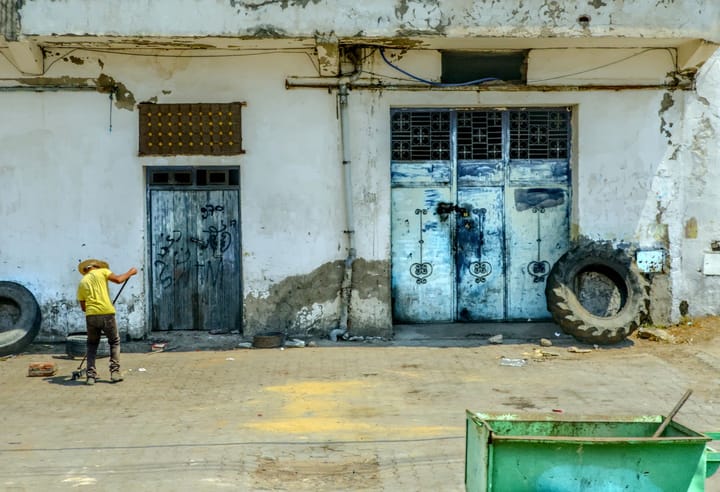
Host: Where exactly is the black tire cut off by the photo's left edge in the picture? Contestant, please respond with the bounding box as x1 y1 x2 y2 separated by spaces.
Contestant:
0 281 42 357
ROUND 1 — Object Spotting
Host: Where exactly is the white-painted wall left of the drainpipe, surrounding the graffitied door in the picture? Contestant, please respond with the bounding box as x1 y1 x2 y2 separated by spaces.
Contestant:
0 48 354 336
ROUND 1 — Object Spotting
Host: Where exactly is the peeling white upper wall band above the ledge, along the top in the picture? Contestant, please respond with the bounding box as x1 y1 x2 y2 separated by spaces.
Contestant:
20 0 720 40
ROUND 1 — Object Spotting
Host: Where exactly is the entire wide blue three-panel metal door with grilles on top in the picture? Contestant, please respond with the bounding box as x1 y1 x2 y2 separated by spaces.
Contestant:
391 109 570 323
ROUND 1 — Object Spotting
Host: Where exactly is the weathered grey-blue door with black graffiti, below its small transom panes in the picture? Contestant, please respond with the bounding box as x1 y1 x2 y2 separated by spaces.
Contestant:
150 189 242 332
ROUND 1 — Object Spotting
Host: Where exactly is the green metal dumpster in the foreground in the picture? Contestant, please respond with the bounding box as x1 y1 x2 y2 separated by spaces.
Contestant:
465 411 720 492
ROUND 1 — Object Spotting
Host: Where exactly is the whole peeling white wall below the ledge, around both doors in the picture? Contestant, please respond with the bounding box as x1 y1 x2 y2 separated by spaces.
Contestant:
0 44 720 339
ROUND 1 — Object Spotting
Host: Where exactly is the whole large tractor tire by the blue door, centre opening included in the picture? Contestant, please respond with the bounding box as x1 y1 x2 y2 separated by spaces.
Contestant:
545 242 650 345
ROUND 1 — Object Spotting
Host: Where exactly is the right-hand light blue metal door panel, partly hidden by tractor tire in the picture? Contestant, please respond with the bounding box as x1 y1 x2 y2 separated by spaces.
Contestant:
506 187 569 320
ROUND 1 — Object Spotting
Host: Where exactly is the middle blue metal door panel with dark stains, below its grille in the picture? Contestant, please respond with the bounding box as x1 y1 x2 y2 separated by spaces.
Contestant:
455 186 505 321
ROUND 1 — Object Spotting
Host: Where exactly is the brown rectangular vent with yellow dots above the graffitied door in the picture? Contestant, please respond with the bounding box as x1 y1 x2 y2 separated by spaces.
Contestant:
139 102 244 155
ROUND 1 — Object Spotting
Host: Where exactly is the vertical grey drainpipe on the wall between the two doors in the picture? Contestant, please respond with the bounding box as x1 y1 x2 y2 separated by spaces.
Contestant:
330 81 360 342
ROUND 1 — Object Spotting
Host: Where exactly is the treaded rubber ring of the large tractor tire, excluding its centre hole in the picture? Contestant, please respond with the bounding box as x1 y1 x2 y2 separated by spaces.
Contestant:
545 242 650 345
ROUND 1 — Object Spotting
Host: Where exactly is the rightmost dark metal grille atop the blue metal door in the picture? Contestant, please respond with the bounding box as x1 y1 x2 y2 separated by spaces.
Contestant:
510 110 569 159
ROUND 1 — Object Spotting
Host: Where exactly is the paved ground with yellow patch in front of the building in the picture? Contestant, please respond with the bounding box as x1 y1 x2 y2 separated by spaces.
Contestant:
0 326 720 492
